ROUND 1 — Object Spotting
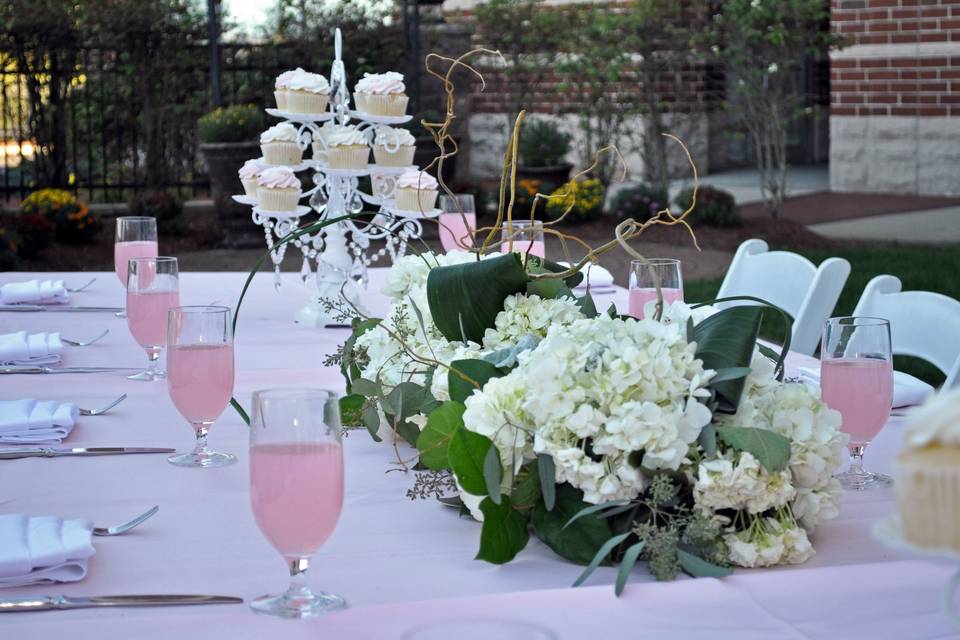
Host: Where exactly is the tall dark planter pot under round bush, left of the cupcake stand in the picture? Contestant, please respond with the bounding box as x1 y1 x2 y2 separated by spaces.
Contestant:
200 142 263 248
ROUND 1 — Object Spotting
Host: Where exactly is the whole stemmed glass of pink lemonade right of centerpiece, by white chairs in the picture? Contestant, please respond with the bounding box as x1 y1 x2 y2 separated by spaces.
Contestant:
820 317 893 491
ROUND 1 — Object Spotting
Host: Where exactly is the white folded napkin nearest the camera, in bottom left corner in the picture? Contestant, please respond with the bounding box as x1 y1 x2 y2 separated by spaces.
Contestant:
0 514 96 587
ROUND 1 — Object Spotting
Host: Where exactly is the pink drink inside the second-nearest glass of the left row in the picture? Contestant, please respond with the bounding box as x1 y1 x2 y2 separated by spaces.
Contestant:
167 344 233 425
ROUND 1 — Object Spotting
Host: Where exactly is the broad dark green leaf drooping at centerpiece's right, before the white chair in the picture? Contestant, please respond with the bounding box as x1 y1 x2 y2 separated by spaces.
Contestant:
693 306 763 413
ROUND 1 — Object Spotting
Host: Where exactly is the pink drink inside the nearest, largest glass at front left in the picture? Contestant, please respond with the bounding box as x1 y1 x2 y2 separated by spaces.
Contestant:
250 442 343 559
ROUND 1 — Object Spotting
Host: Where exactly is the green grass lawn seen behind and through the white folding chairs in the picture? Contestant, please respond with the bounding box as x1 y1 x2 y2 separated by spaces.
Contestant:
683 245 960 385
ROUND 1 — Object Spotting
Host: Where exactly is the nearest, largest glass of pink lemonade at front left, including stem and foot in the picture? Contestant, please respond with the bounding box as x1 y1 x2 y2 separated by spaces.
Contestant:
250 389 346 618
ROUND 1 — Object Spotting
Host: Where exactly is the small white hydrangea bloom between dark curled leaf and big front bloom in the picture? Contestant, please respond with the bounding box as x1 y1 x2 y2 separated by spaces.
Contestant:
483 294 583 351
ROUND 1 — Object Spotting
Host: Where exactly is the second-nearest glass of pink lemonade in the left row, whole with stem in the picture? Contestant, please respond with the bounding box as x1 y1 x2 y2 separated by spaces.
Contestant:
167 306 237 467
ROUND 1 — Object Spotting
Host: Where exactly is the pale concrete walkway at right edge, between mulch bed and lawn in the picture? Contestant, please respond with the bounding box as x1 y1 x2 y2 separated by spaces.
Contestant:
808 207 960 244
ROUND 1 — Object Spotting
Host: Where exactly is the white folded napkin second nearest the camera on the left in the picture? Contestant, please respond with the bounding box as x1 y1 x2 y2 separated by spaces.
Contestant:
0 399 80 444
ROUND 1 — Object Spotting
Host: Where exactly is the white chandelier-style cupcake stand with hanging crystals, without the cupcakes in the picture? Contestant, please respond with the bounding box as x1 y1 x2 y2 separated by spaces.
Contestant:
233 28 440 327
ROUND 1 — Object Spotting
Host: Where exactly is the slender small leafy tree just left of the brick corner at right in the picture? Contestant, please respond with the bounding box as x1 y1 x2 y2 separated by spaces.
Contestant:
700 0 838 217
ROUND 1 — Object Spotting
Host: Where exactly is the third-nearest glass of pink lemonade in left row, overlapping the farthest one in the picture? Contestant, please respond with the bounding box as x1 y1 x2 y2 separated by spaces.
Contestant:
127 256 180 382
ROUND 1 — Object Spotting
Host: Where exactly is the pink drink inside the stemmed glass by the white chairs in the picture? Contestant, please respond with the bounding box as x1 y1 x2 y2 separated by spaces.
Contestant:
820 358 893 445
